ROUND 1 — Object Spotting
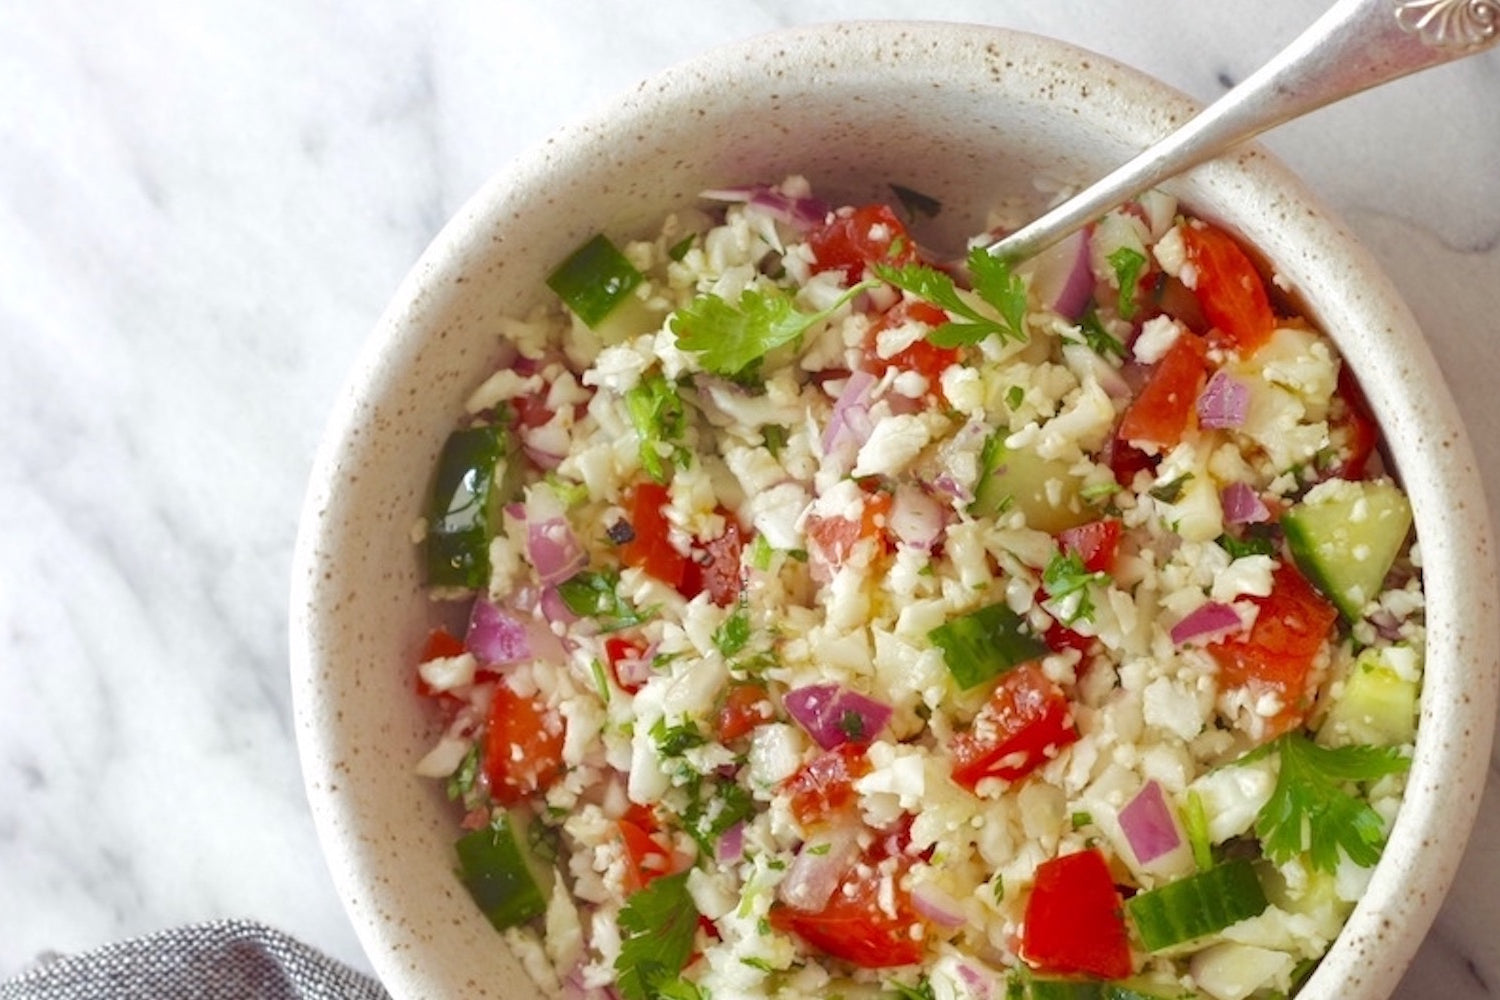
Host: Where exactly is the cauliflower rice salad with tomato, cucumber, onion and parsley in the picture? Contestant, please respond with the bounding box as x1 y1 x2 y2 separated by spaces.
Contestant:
414 177 1424 1000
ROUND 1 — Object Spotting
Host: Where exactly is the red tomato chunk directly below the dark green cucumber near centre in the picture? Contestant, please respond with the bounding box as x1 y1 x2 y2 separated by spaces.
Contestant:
948 663 1079 792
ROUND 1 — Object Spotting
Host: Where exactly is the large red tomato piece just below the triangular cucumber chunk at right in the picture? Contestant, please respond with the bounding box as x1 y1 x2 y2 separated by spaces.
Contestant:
1208 562 1338 736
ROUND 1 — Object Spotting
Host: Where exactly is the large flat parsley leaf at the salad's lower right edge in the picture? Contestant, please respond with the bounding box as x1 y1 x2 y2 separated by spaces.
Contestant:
1256 733 1412 873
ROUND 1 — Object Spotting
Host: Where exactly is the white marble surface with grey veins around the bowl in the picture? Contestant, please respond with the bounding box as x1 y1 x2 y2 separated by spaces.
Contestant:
0 0 1500 1000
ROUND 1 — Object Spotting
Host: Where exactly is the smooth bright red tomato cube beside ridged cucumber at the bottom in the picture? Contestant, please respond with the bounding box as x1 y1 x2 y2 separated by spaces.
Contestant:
1022 847 1131 979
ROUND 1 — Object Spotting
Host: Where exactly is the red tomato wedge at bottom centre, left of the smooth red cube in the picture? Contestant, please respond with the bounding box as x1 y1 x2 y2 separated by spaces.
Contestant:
770 859 923 969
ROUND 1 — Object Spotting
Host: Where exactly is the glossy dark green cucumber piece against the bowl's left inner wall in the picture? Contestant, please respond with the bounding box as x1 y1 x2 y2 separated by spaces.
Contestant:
426 424 521 589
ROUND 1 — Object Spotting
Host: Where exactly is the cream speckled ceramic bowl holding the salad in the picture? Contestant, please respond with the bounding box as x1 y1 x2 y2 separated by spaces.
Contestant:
291 22 1500 1000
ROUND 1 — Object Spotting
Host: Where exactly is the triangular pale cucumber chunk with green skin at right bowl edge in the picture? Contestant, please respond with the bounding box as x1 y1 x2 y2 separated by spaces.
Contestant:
1281 480 1412 622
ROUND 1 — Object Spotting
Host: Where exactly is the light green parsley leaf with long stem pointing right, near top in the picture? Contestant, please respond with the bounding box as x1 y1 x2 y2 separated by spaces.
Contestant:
672 282 867 378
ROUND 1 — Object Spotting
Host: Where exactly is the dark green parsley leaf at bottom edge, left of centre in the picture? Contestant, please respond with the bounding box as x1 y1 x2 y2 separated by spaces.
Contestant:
615 871 701 1000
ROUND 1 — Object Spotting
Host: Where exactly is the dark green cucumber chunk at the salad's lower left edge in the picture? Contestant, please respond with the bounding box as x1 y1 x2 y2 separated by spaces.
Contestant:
458 808 557 930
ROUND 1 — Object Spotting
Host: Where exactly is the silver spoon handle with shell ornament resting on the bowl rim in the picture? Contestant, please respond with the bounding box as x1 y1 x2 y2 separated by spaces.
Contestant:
986 0 1500 261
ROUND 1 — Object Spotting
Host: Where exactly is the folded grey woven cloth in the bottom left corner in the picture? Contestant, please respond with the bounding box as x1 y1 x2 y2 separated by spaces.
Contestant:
0 921 390 1000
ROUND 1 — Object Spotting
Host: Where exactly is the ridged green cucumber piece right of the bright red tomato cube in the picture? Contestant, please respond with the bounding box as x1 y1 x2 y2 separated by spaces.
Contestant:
1125 858 1268 952
